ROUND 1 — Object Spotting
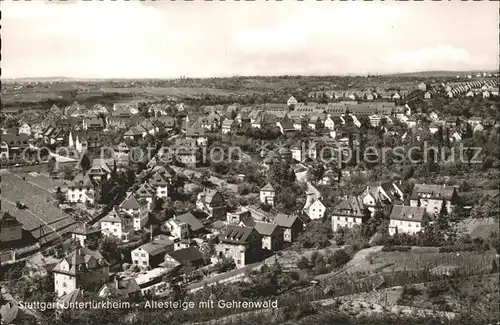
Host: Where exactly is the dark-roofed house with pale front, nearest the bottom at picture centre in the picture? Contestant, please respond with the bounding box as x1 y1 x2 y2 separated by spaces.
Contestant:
218 225 262 268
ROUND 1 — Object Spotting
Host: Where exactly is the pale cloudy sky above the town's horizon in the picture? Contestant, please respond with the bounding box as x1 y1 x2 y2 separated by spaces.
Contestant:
0 0 499 78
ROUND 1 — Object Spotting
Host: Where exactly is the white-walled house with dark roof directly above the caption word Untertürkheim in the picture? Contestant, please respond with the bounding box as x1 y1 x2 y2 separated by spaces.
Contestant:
52 247 109 297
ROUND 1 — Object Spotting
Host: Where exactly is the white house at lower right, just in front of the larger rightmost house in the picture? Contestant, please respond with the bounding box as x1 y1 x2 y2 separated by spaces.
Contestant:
389 205 428 236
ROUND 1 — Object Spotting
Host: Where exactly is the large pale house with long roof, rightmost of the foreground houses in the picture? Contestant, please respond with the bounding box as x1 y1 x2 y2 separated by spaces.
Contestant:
410 183 459 215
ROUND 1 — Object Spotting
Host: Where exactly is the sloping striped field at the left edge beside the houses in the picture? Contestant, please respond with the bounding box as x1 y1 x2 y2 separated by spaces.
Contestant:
0 172 78 244
